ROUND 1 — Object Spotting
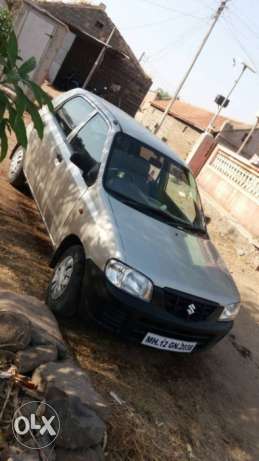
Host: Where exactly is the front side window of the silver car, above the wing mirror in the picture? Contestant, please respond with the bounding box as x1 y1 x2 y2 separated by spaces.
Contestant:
71 114 109 175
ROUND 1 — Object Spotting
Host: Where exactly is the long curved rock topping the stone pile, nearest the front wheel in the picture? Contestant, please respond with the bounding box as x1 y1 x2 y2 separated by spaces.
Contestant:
0 290 68 358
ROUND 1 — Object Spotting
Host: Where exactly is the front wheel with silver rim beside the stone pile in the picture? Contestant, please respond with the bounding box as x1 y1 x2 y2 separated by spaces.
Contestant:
46 245 85 317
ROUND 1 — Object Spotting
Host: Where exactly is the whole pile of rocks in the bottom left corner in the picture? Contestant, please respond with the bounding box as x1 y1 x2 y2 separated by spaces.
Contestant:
0 291 109 461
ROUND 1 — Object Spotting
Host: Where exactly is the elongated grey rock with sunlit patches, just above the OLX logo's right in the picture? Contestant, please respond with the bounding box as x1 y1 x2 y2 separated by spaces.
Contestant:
32 359 110 420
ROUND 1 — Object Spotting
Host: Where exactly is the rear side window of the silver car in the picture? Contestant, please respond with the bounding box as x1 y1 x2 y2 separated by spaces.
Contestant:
55 96 95 136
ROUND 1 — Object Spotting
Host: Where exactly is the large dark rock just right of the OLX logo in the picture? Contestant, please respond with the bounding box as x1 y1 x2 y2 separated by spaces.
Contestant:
46 387 105 450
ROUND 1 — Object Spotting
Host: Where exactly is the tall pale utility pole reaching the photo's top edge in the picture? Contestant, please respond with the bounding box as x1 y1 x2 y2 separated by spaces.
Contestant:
154 0 230 134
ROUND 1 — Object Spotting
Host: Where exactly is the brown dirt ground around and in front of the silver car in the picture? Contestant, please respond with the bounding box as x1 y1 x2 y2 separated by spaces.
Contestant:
0 153 259 461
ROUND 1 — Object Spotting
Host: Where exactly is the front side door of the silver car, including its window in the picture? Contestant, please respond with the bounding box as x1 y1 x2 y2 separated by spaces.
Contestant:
45 113 110 241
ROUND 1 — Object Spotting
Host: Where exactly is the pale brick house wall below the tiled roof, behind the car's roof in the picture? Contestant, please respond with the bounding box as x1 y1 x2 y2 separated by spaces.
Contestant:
137 104 200 160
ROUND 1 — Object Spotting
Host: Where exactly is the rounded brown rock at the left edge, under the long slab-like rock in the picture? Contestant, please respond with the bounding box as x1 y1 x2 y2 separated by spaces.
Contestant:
0 310 32 352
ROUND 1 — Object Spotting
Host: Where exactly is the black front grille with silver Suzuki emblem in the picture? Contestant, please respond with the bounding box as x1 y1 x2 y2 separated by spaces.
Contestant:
165 289 223 322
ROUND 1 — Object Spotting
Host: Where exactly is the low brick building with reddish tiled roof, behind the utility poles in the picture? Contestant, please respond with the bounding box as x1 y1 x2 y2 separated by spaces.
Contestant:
136 91 253 159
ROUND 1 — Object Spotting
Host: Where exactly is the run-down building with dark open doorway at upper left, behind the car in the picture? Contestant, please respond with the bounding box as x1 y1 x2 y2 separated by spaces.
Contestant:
15 0 152 116
